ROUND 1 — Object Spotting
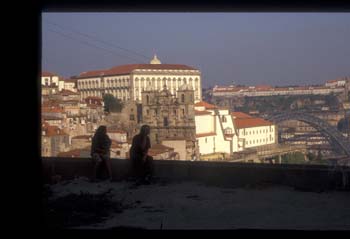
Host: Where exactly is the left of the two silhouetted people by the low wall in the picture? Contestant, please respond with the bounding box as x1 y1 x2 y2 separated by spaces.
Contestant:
91 125 112 181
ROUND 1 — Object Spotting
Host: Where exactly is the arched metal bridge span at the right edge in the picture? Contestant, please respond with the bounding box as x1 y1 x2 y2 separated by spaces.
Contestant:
267 111 350 156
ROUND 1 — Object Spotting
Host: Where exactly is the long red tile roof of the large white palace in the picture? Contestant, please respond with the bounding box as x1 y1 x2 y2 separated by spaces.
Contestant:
77 64 196 78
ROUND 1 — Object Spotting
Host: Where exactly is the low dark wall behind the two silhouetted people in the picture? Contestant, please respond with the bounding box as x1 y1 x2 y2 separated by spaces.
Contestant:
42 158 350 190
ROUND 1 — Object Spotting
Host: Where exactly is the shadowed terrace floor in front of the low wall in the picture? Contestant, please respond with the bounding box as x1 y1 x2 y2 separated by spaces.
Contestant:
44 178 350 230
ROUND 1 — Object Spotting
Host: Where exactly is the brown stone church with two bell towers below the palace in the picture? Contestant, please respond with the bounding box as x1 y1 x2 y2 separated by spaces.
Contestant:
140 84 198 160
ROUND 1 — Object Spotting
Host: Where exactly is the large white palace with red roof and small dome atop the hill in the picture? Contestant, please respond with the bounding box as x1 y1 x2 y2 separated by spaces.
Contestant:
76 55 202 102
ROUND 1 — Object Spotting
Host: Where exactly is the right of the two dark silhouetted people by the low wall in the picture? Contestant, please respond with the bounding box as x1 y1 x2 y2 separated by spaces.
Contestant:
130 125 153 181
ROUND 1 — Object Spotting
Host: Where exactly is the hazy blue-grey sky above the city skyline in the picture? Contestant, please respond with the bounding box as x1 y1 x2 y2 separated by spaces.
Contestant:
42 12 350 87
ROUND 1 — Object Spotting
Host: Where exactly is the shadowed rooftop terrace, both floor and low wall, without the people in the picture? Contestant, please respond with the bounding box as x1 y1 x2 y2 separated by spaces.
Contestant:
43 158 350 230
